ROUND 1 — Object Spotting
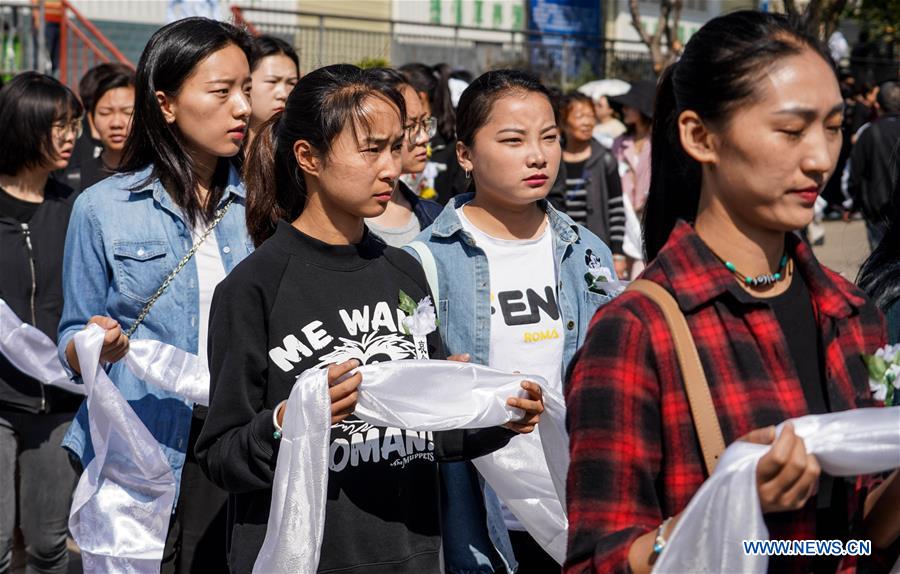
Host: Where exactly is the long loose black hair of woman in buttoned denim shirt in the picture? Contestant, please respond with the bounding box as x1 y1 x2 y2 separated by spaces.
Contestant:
121 18 252 224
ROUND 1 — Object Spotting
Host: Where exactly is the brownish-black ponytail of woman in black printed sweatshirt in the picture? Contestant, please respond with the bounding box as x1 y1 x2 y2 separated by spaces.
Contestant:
243 112 306 247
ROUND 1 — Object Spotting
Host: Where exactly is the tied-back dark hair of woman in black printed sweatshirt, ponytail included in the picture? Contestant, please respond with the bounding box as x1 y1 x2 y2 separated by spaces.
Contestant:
244 64 406 246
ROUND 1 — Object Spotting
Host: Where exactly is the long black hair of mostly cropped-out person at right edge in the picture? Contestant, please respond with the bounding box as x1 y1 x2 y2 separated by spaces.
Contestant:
857 142 900 311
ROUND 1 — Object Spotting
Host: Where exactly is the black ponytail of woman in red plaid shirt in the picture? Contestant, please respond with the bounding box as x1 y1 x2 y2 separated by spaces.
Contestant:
644 62 701 263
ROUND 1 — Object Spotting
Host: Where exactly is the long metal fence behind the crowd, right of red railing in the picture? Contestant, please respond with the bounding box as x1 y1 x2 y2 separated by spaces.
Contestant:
234 7 653 88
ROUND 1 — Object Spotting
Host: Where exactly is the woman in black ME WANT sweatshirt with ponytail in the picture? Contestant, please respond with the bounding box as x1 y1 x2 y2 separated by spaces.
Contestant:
196 65 543 574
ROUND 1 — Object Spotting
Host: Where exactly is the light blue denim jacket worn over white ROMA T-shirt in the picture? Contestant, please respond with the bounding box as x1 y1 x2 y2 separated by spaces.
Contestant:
405 193 615 574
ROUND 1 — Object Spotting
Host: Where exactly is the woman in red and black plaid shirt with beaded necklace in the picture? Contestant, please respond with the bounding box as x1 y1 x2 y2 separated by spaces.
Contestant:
565 11 900 573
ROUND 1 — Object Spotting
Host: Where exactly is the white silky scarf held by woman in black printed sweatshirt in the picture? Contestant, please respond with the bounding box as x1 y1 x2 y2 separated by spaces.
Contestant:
253 360 568 574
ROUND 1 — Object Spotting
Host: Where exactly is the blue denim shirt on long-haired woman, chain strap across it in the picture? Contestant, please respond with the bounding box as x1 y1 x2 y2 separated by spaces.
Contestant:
59 163 253 500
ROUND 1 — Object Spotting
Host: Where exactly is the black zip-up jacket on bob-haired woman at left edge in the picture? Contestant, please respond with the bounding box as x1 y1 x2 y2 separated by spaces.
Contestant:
0 178 82 413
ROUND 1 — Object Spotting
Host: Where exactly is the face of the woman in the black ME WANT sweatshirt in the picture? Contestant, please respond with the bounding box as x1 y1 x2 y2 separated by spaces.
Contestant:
312 96 405 217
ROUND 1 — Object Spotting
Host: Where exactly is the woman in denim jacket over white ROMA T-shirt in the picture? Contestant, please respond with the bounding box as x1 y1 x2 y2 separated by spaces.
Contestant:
406 70 618 574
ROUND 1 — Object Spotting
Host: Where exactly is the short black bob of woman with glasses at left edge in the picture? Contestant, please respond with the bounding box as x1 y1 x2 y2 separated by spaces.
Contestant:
0 72 83 175
